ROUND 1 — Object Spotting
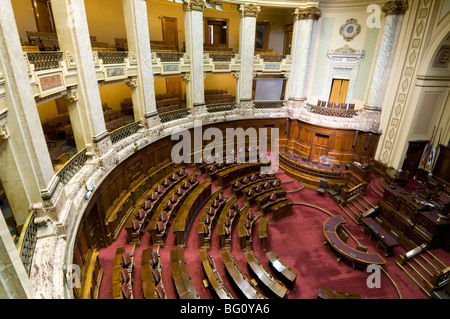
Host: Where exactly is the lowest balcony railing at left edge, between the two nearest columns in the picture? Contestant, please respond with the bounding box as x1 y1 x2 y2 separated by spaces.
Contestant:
17 211 37 276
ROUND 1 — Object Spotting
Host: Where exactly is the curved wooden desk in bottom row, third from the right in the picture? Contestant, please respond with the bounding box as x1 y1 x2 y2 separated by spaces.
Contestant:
222 250 267 299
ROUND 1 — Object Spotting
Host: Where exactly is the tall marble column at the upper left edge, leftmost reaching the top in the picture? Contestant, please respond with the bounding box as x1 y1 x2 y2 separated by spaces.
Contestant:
0 1 58 224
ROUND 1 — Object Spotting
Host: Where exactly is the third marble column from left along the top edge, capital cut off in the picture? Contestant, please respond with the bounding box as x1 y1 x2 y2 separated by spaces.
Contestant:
122 0 160 128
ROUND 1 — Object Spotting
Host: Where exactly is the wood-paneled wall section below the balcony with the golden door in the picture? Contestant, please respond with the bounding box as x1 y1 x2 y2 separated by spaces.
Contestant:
286 120 379 166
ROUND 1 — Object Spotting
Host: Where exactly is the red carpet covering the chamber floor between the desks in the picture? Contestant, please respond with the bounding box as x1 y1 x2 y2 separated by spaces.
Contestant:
99 168 450 299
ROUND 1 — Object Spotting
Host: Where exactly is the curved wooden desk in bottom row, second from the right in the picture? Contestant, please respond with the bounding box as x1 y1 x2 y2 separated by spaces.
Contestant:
244 251 289 299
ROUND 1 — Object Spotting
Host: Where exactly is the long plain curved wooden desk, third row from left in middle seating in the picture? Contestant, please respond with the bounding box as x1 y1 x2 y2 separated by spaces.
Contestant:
172 181 211 247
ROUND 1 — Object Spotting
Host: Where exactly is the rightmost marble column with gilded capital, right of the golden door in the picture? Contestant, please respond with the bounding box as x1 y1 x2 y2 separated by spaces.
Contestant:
364 1 408 112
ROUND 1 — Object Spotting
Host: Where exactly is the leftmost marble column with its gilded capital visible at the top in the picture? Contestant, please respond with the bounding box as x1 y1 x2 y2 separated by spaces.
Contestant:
183 0 206 116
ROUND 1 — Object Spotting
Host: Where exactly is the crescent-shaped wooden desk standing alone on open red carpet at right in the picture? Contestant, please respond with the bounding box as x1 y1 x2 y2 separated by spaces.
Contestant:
323 215 386 268
